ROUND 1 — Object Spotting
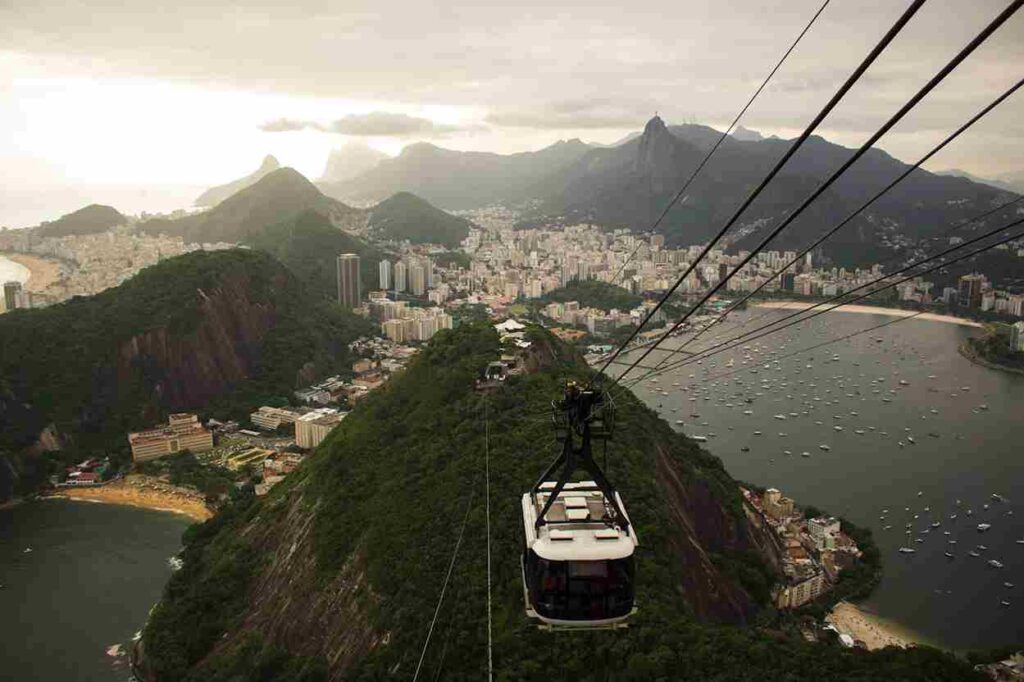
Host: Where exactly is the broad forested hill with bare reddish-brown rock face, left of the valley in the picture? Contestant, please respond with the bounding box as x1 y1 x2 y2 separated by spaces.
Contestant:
0 250 369 497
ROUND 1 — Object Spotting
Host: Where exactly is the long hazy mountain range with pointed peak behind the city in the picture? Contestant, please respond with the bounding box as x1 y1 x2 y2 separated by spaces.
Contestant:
325 117 1007 265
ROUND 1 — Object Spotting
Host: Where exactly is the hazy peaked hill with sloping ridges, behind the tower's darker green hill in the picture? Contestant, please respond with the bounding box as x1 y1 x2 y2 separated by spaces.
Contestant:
139 168 366 244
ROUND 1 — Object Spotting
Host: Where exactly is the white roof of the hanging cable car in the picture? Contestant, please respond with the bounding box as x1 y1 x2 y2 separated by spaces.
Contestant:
522 480 639 561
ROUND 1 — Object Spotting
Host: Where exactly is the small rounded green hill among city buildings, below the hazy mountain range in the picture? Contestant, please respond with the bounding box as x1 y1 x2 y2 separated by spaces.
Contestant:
370 191 472 249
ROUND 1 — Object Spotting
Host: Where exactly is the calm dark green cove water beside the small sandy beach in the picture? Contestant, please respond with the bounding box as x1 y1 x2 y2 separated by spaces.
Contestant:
0 500 190 682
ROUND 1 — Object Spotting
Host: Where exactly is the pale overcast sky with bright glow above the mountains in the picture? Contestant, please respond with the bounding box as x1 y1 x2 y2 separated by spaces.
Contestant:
0 0 1024 222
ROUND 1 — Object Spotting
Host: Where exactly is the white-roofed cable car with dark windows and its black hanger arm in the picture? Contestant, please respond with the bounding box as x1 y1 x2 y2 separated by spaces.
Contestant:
521 384 638 630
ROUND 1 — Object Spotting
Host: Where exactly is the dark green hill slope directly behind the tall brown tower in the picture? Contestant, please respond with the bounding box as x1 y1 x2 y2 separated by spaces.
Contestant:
246 211 385 300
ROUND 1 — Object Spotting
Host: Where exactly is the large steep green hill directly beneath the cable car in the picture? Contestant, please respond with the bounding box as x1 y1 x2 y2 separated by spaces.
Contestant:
141 325 977 682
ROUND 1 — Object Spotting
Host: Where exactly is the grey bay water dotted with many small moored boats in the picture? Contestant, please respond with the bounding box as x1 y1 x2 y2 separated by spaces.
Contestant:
622 309 1024 650
